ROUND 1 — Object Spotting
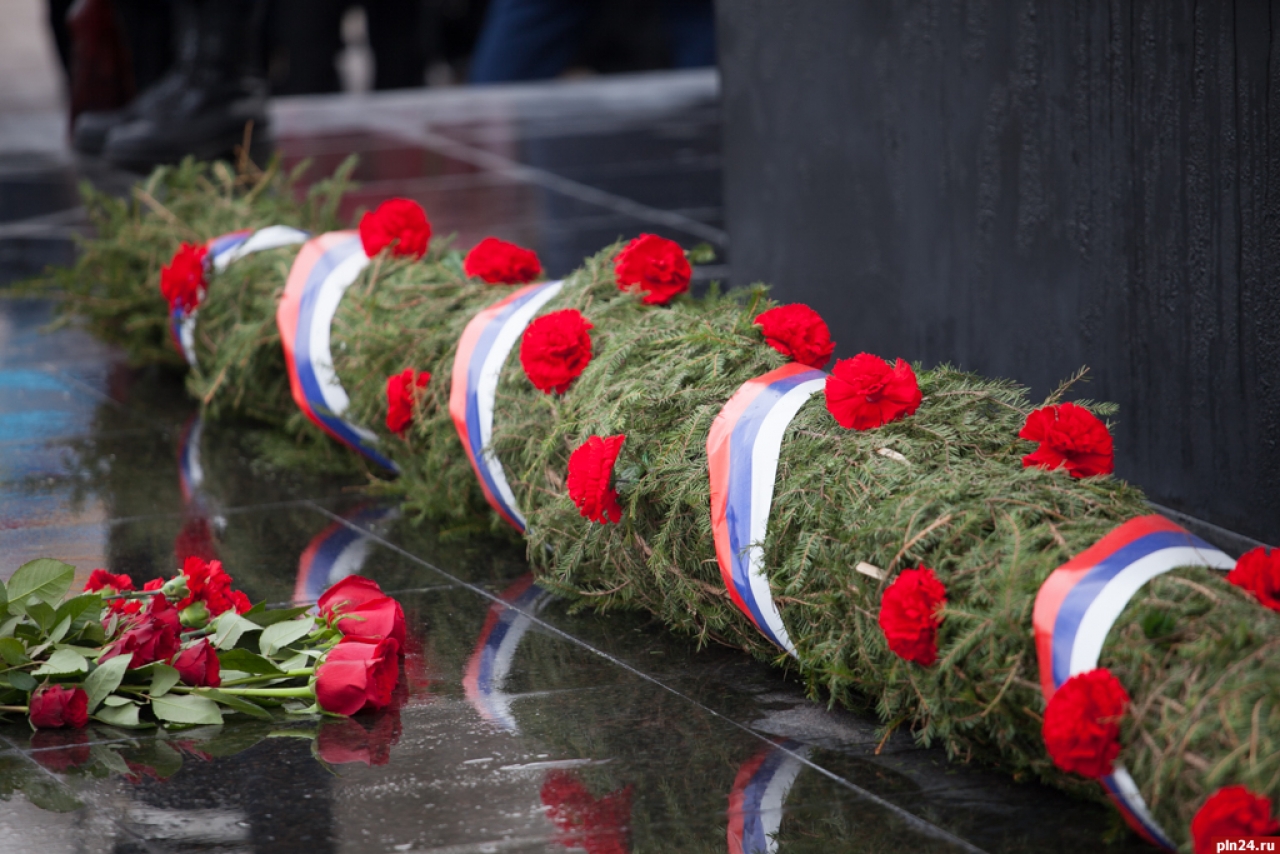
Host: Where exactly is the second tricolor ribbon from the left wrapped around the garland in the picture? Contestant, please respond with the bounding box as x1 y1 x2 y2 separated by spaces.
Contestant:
275 232 398 471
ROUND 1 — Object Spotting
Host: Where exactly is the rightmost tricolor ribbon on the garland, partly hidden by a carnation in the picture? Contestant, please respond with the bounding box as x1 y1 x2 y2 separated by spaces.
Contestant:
1032 516 1235 850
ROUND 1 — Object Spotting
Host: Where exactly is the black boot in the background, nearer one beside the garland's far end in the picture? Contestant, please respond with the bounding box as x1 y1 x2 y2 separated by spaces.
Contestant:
102 0 268 169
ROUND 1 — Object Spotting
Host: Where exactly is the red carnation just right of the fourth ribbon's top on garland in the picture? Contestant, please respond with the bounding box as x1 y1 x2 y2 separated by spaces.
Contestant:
826 353 923 430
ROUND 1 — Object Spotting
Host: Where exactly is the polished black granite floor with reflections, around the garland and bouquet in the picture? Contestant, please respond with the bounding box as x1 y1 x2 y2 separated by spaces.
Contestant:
0 74 1144 854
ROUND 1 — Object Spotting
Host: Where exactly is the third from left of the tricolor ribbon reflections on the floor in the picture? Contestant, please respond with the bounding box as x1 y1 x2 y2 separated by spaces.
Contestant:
462 572 552 732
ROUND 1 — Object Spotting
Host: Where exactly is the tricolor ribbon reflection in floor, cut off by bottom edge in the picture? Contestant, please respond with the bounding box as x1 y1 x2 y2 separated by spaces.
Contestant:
728 739 809 854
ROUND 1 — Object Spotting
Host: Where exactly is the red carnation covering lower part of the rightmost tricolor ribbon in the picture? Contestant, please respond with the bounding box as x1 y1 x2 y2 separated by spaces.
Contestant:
1041 667 1129 780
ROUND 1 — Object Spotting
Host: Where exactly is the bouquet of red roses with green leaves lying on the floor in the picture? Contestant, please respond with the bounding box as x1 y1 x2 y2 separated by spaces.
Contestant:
0 557 404 729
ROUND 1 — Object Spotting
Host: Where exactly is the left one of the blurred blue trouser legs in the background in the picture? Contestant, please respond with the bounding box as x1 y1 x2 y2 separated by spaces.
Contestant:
468 0 595 83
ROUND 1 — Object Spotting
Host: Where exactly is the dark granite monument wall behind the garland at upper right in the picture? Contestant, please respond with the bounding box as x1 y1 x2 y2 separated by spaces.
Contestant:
717 0 1280 544
